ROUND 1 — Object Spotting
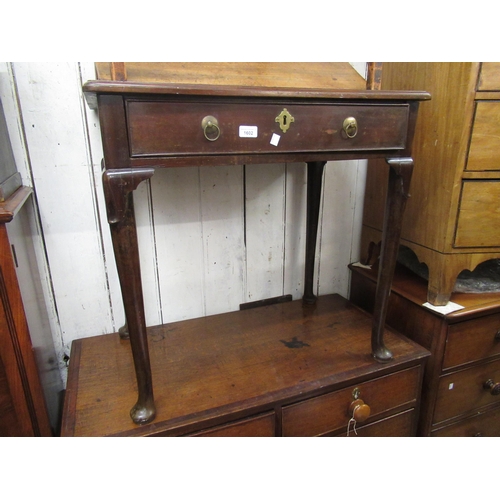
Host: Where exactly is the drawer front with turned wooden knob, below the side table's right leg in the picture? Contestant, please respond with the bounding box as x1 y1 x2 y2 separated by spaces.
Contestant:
282 368 419 436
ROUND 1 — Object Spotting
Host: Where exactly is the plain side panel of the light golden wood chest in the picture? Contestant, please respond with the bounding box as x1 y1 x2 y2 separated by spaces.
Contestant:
363 63 475 252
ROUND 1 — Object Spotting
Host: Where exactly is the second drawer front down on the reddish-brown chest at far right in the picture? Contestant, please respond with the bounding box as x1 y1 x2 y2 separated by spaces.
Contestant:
434 361 500 423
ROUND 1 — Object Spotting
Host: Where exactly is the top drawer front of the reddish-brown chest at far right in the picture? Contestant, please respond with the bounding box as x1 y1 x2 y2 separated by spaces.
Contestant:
443 314 500 368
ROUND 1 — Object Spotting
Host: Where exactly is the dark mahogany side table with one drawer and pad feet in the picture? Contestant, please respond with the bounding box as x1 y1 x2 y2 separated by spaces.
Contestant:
84 61 430 424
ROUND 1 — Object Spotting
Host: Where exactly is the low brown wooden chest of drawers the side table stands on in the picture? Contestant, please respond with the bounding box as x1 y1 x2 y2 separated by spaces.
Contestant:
62 295 429 436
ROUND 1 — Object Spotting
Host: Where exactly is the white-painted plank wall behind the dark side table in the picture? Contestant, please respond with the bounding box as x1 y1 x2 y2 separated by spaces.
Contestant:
0 62 365 390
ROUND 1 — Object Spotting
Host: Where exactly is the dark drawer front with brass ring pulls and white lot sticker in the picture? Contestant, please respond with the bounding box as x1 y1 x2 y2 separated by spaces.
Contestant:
127 100 409 157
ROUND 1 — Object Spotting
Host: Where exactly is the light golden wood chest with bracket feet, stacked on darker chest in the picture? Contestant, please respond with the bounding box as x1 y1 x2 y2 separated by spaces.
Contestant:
362 63 500 305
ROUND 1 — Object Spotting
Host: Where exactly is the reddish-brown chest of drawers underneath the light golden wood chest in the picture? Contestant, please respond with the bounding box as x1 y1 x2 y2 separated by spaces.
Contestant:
351 266 500 436
